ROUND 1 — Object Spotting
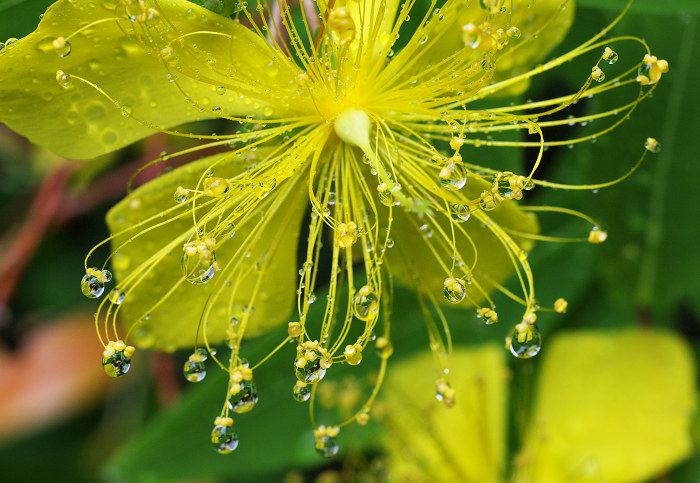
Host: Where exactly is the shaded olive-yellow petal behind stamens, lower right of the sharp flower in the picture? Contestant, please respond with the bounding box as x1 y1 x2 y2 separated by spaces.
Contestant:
385 178 539 308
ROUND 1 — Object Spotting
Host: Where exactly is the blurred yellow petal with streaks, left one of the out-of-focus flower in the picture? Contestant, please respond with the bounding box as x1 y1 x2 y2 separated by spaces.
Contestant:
377 346 507 482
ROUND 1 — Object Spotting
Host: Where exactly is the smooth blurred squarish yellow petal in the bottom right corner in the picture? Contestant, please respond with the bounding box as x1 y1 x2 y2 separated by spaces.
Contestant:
516 330 696 483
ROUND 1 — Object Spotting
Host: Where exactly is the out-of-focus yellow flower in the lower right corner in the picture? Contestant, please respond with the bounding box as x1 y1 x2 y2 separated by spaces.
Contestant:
377 329 697 483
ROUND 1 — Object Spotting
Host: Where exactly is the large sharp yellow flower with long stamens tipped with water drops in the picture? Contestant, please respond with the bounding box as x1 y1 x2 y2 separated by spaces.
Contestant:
0 0 668 455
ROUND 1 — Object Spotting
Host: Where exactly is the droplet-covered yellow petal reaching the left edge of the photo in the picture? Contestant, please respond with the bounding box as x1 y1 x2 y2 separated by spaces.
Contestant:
0 0 296 159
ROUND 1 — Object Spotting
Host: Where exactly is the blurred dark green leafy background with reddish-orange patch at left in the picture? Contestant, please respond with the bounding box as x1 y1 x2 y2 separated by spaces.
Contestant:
0 0 700 482
